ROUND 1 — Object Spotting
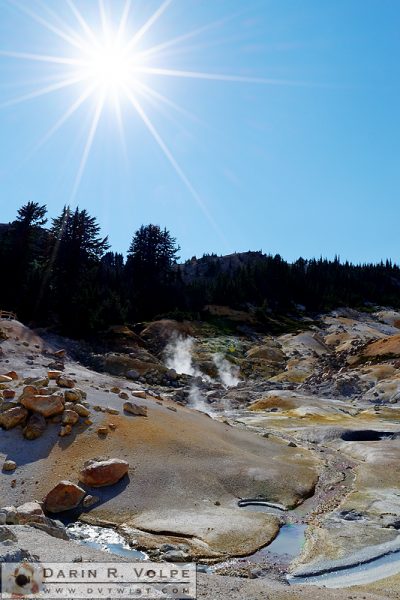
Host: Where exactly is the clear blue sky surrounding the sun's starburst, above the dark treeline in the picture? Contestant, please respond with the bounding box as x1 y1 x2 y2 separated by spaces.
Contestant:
0 0 400 261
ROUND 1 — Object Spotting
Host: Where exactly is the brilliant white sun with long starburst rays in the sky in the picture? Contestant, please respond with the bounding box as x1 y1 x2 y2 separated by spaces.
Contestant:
0 0 308 235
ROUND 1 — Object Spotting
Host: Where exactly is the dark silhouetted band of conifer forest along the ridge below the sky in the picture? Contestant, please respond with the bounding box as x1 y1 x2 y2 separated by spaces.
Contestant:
0 202 400 336
